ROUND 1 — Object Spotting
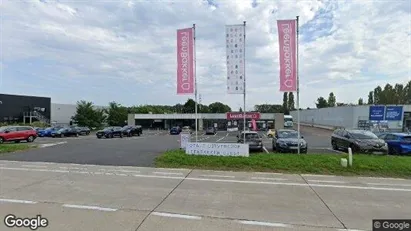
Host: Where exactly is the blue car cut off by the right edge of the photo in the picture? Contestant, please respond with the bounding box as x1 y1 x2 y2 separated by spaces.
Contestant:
378 133 411 155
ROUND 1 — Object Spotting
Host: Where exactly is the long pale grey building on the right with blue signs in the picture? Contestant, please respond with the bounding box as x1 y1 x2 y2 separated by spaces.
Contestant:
290 105 411 131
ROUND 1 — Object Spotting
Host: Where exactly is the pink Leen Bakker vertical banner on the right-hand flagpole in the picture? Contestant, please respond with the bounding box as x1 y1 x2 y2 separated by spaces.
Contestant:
277 19 297 92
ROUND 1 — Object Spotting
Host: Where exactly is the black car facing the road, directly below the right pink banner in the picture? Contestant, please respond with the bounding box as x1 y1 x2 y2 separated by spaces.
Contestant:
272 129 308 153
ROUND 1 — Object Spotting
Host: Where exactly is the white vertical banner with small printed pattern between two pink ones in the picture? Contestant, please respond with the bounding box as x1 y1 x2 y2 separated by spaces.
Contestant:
226 24 245 94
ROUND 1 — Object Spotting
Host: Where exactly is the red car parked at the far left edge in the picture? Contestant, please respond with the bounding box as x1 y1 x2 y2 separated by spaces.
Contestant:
0 126 37 144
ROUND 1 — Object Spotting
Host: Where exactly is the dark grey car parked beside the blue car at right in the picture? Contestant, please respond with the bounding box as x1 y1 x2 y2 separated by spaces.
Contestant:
331 129 388 154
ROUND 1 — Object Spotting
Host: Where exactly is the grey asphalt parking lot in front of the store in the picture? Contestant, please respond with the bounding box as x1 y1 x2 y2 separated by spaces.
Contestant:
0 127 336 167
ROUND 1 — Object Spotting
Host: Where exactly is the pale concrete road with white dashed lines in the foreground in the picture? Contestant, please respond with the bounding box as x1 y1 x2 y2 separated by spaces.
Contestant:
0 161 411 231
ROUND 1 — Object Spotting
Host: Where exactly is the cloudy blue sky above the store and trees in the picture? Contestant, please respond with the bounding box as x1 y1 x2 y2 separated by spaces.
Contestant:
0 0 411 110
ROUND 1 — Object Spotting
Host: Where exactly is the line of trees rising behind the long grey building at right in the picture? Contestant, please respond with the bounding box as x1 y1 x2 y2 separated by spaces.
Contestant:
316 81 411 109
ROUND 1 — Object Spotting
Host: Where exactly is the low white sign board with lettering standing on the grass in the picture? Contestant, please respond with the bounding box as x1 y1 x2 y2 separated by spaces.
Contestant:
186 142 250 157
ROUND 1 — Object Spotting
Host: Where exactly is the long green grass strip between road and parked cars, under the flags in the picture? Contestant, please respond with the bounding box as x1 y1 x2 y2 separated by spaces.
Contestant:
155 150 411 178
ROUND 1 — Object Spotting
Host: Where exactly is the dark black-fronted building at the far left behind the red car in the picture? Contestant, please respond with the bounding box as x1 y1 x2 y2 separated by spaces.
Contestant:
0 94 51 123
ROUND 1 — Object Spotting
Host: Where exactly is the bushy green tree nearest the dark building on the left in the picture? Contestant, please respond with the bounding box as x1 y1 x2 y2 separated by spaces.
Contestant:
72 100 106 128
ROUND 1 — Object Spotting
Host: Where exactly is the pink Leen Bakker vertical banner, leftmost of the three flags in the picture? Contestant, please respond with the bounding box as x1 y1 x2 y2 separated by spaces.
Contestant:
177 28 194 95
